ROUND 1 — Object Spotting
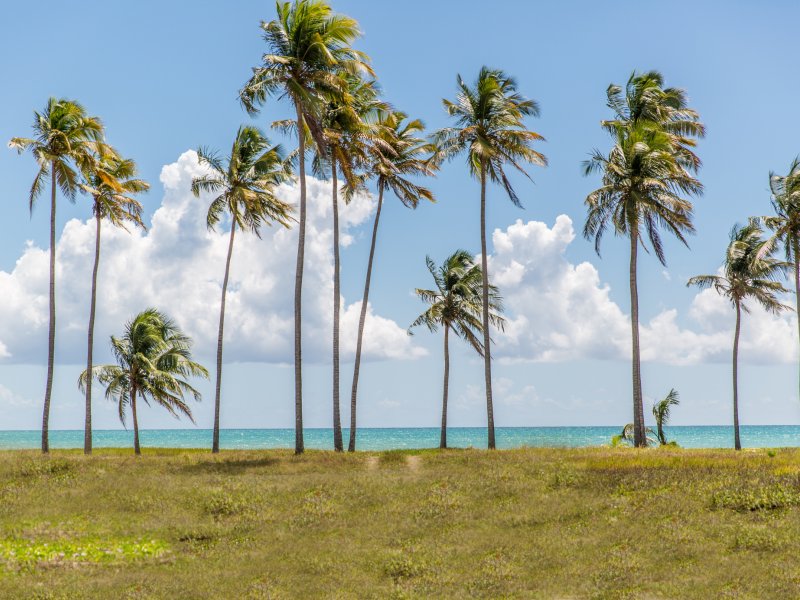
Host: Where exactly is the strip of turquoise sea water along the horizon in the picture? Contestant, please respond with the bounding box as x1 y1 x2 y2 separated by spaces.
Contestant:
0 425 800 450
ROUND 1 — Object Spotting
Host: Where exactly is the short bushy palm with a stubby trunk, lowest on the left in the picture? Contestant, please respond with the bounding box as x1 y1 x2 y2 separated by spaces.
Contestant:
78 308 208 455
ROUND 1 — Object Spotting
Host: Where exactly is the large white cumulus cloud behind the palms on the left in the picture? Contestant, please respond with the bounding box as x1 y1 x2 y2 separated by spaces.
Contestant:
0 151 425 363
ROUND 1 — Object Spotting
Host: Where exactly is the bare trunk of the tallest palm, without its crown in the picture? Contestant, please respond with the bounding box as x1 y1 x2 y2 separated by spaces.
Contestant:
294 101 306 454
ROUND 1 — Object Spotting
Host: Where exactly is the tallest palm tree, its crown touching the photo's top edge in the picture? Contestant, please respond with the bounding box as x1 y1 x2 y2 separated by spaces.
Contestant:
239 0 372 454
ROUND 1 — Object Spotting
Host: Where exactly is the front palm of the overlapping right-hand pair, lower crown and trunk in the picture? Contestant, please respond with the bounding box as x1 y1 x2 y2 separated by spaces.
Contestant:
583 123 703 446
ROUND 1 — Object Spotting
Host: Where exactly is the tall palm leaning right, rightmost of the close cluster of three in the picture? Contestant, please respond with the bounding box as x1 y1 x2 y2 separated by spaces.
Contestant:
347 112 436 452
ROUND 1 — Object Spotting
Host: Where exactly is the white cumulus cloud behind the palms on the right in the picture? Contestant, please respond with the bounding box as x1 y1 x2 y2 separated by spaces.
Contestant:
489 215 797 365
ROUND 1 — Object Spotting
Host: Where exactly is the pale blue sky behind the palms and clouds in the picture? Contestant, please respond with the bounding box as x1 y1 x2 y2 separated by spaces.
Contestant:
0 0 800 428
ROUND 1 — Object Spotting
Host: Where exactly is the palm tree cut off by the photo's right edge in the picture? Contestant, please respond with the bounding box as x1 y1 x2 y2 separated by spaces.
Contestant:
764 158 800 400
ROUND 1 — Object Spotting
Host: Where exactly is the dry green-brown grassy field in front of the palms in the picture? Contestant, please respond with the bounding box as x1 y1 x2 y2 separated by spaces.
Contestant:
0 449 800 599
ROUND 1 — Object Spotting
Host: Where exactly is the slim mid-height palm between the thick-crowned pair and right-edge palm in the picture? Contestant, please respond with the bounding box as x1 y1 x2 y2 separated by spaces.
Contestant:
686 219 791 450
